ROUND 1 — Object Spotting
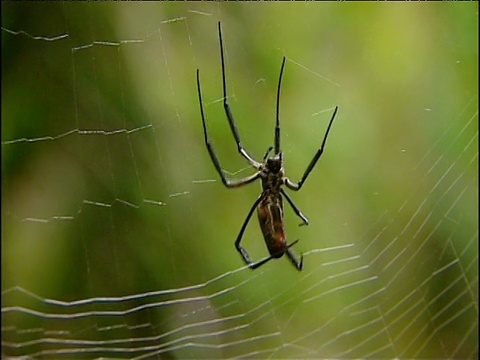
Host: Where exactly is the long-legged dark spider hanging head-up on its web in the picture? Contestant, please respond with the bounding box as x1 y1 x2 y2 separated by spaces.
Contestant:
197 22 338 271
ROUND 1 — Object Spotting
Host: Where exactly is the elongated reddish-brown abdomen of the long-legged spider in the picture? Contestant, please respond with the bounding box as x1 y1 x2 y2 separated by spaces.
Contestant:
257 194 288 258
